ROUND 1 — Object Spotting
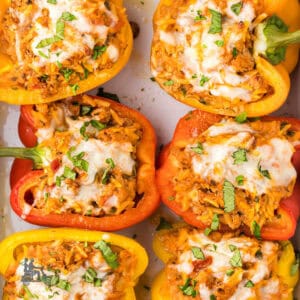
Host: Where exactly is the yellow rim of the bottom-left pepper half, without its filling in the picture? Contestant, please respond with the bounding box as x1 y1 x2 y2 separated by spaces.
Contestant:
0 228 148 300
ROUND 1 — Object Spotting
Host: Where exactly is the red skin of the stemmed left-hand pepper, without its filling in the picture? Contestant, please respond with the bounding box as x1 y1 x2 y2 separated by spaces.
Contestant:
10 98 160 231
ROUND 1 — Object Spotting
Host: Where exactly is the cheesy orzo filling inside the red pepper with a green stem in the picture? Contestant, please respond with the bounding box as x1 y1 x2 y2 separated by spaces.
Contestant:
24 96 143 217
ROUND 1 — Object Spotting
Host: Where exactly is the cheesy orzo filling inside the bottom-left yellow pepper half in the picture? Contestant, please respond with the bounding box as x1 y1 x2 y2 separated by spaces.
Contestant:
4 240 136 300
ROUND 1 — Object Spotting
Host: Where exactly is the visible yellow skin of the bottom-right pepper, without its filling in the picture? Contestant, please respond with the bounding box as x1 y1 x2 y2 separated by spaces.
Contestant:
151 223 299 300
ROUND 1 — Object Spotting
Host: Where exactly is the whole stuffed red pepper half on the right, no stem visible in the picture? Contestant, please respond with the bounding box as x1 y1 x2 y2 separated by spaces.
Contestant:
157 110 300 240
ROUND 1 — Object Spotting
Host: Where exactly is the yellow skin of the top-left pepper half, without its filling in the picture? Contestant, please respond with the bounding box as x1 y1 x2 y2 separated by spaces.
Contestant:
0 0 133 105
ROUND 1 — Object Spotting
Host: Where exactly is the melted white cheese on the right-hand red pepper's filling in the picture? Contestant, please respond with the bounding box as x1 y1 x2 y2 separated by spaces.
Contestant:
190 122 297 196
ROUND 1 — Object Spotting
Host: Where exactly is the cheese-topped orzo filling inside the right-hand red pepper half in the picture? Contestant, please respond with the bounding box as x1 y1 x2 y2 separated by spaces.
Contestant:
169 118 300 232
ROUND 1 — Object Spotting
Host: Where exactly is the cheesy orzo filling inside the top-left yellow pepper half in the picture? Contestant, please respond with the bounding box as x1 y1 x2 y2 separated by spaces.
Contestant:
0 0 128 96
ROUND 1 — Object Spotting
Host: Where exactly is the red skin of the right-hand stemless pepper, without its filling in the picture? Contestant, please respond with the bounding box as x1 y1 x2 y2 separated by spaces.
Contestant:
156 110 300 240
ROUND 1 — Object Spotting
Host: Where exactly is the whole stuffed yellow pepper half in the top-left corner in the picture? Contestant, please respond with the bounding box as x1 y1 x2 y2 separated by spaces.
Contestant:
0 0 133 104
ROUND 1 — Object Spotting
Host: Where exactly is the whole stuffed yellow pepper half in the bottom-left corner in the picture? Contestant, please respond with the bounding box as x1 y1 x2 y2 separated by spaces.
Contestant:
0 228 148 300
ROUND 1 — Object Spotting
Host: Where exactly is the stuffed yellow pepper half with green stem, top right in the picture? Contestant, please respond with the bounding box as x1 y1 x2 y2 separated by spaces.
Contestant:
151 0 300 117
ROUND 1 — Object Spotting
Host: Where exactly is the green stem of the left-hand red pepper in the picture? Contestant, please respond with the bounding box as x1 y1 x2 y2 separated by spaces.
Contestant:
0 147 51 169
